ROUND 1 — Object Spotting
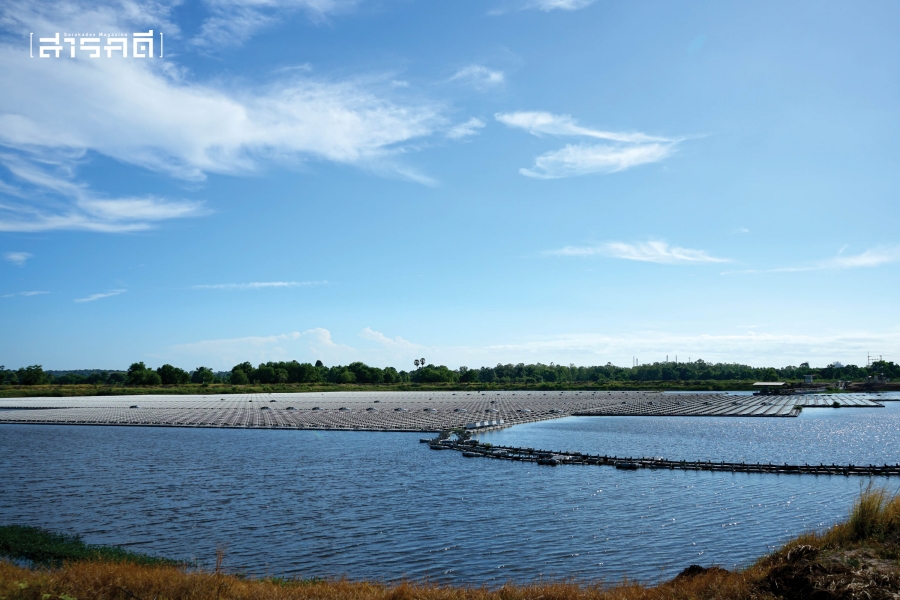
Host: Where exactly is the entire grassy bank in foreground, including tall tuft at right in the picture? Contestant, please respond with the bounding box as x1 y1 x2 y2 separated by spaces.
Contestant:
0 487 900 600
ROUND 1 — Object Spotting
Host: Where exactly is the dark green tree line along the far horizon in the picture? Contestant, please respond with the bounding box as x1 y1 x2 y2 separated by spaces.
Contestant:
0 359 900 386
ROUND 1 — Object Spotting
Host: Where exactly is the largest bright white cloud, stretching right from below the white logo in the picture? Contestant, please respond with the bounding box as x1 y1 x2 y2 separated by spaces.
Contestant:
0 52 439 179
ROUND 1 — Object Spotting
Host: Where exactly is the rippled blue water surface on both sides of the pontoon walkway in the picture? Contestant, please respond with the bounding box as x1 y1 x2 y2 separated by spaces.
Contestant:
0 404 900 584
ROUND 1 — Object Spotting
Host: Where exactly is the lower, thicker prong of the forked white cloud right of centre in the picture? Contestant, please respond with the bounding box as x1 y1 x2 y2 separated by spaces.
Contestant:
519 144 672 179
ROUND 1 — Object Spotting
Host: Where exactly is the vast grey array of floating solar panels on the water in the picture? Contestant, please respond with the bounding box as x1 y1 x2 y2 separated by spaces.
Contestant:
0 391 883 432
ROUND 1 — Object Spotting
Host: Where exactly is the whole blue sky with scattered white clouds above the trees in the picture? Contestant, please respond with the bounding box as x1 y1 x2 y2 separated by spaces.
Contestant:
0 0 900 369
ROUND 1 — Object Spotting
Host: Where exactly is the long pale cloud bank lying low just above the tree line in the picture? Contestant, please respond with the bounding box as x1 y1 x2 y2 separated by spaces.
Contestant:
163 327 900 370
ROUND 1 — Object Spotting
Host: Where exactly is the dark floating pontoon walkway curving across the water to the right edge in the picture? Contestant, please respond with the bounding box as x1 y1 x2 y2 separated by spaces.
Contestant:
423 440 900 477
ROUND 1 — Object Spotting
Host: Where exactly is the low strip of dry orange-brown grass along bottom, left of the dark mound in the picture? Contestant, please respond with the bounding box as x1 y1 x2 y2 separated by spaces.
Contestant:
0 562 759 600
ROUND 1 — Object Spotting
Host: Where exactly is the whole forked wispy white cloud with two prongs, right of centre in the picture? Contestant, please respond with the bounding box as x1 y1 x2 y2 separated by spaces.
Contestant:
494 111 682 179
